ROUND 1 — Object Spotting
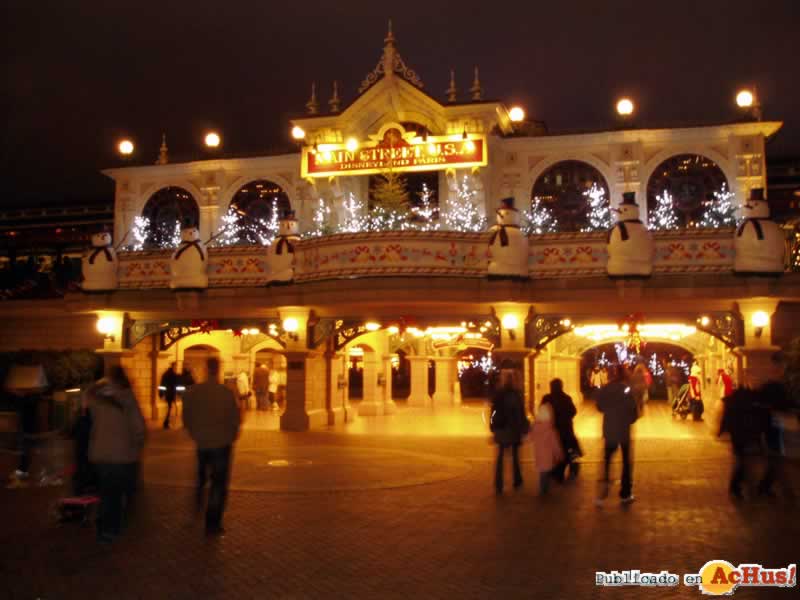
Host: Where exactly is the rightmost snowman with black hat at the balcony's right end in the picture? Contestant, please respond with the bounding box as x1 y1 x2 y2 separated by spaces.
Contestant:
733 188 784 274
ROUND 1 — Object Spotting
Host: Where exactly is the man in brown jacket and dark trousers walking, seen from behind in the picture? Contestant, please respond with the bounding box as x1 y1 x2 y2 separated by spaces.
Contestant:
183 358 241 535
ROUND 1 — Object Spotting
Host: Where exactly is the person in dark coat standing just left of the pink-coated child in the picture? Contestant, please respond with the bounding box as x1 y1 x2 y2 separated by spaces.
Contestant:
490 369 530 494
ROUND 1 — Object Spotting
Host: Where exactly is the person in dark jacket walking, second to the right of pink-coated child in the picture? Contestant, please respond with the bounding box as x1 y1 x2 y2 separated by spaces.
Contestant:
596 372 639 505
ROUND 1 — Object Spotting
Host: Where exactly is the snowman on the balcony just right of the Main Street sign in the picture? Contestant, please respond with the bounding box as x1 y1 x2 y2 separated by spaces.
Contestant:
489 198 528 277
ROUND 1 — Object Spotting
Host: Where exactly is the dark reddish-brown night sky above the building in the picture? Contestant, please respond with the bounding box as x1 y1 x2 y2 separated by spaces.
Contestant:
0 0 800 206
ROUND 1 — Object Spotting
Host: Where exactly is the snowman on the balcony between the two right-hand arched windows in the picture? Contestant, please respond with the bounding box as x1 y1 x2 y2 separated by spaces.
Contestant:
606 192 653 277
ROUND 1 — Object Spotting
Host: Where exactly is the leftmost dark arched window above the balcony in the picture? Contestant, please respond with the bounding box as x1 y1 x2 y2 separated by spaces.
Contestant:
142 186 200 248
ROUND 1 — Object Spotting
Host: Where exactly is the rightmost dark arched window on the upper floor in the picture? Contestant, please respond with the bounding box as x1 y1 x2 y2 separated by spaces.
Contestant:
647 154 730 227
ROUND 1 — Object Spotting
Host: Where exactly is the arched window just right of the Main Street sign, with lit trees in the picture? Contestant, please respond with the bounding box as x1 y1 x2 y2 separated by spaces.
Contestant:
531 160 610 233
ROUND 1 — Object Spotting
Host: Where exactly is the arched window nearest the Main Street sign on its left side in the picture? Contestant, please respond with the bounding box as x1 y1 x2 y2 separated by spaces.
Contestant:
228 179 292 244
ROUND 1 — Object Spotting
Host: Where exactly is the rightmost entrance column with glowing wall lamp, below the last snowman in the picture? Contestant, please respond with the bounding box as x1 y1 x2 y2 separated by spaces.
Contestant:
736 298 780 387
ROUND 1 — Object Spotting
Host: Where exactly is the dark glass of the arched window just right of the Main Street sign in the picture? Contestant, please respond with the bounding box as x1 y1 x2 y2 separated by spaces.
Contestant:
531 160 608 231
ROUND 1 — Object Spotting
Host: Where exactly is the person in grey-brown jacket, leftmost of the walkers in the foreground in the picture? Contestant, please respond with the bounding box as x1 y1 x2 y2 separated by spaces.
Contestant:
89 366 145 543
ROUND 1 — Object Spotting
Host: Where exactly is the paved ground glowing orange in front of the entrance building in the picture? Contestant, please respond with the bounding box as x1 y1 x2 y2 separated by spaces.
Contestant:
0 406 800 599
